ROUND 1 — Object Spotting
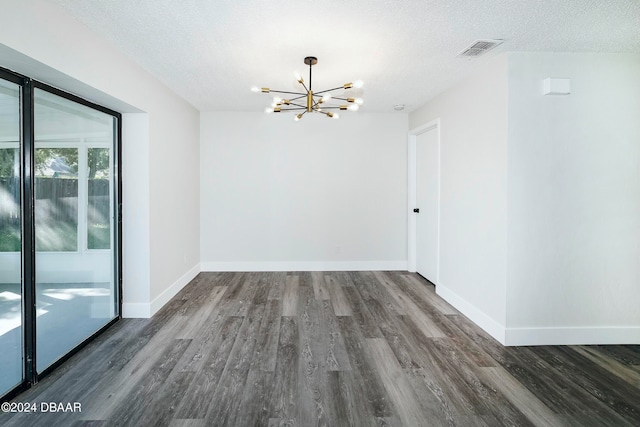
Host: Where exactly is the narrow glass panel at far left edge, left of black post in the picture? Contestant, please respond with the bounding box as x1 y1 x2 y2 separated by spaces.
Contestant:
0 80 23 395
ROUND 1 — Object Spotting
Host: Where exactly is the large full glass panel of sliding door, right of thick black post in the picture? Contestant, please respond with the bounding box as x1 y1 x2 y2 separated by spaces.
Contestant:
34 89 117 372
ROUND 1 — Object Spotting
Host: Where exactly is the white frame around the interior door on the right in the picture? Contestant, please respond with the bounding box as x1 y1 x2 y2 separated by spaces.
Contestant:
407 118 442 278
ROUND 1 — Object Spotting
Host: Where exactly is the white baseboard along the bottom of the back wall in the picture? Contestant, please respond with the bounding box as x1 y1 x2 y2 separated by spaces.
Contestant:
201 260 407 271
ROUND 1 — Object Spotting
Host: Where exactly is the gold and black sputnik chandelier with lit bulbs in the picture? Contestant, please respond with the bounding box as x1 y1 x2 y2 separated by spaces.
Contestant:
251 56 362 121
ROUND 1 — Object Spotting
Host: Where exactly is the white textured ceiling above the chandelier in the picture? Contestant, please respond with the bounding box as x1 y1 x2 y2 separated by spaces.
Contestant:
49 0 640 112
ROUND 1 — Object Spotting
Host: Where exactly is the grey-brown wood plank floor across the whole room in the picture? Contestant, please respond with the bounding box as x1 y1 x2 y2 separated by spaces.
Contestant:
0 272 640 427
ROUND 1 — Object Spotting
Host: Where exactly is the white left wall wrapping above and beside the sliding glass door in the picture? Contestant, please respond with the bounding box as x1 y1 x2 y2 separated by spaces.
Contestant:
0 0 200 316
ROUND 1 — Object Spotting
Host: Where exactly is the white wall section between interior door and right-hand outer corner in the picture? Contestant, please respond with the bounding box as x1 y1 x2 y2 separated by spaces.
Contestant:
409 56 507 341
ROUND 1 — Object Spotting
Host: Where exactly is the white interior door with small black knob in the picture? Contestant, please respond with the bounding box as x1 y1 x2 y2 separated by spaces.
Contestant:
415 127 440 283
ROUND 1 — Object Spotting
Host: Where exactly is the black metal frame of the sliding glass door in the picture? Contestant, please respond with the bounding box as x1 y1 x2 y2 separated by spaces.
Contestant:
0 67 122 402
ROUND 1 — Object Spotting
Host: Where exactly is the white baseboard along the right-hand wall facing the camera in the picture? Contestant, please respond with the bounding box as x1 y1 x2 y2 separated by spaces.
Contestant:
505 326 640 346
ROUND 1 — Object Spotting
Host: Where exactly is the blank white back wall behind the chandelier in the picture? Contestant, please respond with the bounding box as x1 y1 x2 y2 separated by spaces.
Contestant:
200 111 407 271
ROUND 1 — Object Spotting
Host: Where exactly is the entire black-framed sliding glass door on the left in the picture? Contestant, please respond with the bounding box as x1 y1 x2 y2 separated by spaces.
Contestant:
0 69 121 399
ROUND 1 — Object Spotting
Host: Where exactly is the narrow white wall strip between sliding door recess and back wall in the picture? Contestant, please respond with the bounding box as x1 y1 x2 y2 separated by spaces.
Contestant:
149 94 200 312
